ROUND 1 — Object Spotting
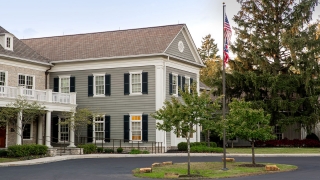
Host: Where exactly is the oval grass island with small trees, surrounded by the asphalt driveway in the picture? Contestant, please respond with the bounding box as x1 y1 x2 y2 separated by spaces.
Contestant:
133 162 298 178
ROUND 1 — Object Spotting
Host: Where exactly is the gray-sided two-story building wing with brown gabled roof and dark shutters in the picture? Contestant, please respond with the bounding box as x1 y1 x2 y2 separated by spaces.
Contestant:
0 24 203 149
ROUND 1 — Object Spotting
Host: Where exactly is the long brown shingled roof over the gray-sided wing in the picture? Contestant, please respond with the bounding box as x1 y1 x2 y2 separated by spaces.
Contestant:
22 24 185 62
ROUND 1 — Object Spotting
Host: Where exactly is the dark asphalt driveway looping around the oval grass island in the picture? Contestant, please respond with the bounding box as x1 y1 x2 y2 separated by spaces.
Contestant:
0 157 320 180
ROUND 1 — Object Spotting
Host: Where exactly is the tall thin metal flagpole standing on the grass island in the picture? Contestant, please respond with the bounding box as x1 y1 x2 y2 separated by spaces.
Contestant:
222 2 228 171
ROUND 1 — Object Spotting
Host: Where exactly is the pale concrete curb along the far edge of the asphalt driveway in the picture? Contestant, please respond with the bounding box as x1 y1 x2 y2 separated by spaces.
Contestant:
0 153 320 167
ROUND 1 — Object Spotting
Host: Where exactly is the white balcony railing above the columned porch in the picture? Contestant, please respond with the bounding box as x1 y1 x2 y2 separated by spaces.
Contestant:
0 86 76 104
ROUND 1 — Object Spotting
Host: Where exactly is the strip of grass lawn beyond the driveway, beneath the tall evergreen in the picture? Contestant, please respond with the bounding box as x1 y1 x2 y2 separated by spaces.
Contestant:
226 147 320 154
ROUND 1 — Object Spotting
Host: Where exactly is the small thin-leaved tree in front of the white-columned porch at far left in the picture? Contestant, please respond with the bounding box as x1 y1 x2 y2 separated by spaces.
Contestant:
0 96 45 144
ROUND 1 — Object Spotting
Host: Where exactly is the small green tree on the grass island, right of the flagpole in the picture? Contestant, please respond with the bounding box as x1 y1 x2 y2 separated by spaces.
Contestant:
223 99 274 164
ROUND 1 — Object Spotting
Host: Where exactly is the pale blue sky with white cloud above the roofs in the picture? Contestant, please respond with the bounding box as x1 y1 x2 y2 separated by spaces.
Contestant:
0 0 320 55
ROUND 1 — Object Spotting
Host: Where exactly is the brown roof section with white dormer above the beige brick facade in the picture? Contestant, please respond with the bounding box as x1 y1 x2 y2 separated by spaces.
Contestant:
0 26 48 63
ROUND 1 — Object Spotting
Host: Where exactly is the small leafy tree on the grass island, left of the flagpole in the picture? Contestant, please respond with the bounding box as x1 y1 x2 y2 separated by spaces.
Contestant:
151 83 219 175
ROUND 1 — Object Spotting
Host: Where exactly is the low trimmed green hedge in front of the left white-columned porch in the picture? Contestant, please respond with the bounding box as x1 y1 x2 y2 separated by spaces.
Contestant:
8 144 48 157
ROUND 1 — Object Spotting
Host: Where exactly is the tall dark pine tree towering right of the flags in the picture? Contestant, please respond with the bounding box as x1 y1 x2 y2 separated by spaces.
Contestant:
226 0 320 134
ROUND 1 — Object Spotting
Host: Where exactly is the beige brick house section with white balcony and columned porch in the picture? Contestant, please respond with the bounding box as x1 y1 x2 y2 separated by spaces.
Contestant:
0 27 76 148
